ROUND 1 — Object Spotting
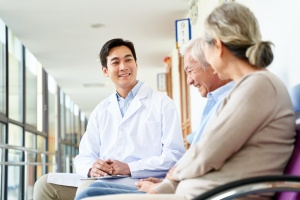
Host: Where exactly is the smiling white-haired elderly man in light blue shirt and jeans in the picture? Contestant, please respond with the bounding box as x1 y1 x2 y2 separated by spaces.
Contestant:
75 38 234 200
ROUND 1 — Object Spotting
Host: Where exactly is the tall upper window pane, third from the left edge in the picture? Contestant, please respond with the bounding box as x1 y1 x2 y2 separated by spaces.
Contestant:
25 49 40 127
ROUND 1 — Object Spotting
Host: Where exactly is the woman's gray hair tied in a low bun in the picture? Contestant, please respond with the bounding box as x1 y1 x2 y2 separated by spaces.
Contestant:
205 2 273 68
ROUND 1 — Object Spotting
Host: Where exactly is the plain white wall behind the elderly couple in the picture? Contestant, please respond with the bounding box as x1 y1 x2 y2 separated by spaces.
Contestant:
173 0 300 131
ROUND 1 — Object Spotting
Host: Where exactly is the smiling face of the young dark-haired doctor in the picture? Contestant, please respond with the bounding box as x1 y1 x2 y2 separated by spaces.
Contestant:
102 46 138 91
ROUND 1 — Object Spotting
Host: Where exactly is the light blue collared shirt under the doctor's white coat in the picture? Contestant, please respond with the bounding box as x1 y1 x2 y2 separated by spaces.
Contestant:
116 81 143 117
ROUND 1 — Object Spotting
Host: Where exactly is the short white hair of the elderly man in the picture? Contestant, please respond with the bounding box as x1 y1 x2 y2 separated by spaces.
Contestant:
180 37 210 70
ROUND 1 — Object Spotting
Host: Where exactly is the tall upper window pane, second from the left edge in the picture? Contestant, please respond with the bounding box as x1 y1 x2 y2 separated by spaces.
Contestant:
8 31 23 122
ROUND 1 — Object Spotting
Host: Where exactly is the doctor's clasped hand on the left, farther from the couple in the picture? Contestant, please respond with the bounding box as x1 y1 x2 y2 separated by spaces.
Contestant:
89 159 113 177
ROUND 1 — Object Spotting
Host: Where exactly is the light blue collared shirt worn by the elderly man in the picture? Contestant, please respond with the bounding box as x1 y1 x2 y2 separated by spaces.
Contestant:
191 81 234 145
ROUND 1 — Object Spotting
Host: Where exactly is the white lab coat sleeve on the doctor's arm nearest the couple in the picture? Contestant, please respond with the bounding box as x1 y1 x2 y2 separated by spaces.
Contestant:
128 97 185 178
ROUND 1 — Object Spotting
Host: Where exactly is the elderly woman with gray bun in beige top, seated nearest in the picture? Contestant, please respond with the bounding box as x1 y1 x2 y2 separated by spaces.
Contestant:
77 3 295 200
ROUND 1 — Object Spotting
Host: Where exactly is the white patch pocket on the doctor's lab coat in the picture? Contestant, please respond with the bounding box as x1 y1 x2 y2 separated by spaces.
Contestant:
137 120 162 147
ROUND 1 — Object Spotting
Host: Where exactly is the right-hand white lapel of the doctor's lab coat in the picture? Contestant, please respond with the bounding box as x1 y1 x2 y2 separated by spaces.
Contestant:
121 85 148 123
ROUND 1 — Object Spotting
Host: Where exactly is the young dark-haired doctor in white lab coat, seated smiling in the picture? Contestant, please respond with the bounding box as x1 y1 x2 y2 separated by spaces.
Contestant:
34 38 185 200
